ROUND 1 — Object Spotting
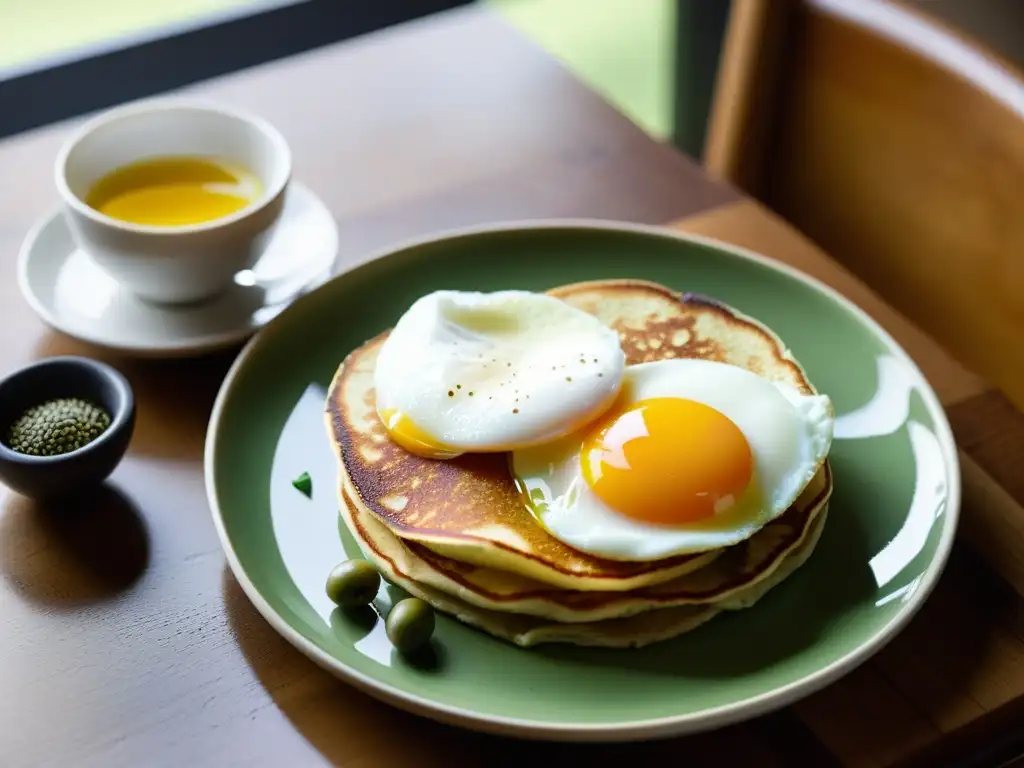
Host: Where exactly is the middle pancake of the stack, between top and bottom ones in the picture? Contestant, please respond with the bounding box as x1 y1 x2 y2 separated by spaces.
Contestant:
342 456 831 623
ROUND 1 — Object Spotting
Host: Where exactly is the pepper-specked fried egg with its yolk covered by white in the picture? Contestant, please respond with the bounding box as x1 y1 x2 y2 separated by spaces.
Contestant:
374 291 626 459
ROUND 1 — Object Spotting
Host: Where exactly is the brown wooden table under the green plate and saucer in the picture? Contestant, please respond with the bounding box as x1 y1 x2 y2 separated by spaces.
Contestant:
0 8 1024 768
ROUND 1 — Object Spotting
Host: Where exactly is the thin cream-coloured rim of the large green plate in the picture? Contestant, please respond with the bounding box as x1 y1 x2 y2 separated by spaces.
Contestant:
203 218 961 741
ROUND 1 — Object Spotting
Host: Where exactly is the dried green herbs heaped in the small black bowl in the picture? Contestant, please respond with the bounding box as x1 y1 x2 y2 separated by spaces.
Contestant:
7 397 111 456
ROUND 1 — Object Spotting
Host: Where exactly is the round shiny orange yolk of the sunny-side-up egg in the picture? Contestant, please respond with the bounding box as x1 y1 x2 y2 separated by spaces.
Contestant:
581 397 754 525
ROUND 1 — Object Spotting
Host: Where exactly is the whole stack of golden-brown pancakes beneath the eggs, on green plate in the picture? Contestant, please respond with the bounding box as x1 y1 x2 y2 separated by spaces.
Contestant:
327 281 833 647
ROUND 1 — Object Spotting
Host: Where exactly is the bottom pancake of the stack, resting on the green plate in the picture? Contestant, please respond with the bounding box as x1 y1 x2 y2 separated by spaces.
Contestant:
341 483 828 648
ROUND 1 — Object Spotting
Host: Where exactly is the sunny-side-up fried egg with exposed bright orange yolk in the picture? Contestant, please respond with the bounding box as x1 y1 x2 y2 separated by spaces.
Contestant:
510 359 834 560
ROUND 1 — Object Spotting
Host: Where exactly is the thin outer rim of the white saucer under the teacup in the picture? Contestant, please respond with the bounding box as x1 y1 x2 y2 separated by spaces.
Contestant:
17 179 339 358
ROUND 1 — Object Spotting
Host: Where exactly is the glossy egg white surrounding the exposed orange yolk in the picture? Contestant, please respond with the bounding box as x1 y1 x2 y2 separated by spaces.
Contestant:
510 359 834 561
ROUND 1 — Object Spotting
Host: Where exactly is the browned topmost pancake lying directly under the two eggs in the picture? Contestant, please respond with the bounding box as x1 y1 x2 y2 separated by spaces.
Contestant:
326 281 827 592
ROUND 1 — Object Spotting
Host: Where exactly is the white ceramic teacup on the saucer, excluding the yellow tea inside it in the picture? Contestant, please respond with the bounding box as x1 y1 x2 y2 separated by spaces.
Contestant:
54 99 292 303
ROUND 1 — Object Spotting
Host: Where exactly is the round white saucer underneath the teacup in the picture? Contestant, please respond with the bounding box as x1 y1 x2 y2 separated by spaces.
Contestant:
17 181 338 357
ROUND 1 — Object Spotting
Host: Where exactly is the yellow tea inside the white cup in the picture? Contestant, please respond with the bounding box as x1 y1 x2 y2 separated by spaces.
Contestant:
85 157 262 226
